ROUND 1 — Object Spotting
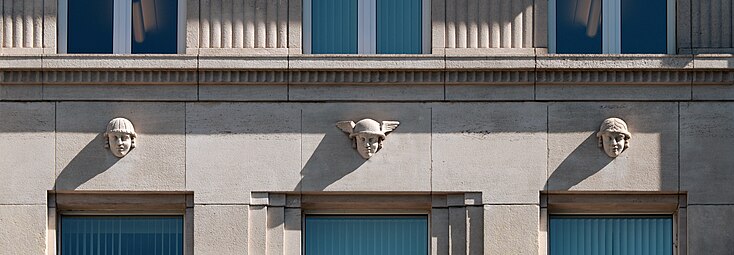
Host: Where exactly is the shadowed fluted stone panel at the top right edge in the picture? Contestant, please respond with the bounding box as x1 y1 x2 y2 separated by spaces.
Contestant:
691 0 734 48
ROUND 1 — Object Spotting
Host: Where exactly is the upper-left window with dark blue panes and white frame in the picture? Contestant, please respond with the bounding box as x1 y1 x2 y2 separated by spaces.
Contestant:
59 0 184 54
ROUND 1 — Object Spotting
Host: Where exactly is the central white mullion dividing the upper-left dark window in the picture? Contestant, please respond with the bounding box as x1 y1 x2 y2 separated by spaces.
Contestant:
112 0 132 54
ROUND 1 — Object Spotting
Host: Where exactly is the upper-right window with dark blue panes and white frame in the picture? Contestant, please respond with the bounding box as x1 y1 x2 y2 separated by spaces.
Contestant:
548 0 675 54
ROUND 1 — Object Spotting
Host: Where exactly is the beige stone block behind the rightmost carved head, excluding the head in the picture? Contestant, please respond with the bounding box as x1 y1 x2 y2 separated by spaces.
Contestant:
548 102 678 191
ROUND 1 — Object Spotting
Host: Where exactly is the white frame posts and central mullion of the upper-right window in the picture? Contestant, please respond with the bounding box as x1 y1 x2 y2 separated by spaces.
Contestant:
548 0 676 54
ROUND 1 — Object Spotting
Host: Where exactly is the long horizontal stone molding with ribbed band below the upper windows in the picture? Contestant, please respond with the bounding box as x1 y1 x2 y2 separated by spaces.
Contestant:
0 55 734 85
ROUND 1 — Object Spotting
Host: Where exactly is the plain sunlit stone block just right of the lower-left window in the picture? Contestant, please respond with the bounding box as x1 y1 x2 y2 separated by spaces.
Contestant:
193 205 249 255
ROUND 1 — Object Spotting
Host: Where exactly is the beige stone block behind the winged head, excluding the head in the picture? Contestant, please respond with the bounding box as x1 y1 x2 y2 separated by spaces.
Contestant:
301 103 431 191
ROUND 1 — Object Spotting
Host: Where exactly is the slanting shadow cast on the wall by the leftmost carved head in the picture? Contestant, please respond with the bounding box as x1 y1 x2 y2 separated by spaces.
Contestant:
54 133 122 190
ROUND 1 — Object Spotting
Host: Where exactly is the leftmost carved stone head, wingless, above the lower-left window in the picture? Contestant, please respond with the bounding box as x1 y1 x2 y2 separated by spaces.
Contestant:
105 118 138 158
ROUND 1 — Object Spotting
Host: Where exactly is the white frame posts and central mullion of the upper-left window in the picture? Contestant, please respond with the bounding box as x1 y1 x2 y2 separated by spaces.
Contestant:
57 0 186 54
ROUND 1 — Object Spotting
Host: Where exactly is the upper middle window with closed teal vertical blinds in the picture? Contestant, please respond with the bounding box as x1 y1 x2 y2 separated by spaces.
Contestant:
303 0 430 54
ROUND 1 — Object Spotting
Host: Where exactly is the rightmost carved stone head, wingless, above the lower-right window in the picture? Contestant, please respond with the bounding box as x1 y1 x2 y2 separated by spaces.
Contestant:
596 118 632 158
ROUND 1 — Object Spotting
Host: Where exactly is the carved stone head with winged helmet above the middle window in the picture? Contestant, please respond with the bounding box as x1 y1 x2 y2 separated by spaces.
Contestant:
336 119 400 159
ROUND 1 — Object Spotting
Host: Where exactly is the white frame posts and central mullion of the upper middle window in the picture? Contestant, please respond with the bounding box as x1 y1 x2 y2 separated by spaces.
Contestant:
303 0 431 54
